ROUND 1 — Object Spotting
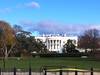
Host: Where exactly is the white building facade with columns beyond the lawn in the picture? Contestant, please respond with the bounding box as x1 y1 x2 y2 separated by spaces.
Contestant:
35 35 78 53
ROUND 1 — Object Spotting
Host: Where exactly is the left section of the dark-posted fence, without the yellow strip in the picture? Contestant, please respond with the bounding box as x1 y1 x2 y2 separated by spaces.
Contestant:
0 67 41 75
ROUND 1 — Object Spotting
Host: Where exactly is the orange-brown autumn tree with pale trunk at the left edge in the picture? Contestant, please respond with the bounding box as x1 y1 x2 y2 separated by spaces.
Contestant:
0 21 16 59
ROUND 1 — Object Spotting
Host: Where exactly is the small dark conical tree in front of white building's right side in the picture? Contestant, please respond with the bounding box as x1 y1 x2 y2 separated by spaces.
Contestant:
63 39 78 53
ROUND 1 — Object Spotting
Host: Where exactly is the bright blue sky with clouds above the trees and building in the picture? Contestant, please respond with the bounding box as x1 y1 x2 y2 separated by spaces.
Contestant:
0 0 100 34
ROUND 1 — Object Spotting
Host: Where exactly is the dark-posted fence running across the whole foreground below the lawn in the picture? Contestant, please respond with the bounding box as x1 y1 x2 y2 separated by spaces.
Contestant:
0 67 100 75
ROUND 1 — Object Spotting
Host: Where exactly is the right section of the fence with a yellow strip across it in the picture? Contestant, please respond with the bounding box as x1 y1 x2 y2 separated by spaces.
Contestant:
43 66 100 75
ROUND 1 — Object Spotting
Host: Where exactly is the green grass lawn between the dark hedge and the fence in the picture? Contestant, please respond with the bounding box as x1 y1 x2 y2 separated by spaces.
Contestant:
0 57 100 70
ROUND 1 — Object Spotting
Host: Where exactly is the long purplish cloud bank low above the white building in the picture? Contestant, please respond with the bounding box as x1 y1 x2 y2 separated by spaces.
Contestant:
21 21 100 34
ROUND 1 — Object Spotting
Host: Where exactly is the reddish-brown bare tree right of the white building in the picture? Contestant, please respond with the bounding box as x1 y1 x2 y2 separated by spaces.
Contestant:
78 29 100 52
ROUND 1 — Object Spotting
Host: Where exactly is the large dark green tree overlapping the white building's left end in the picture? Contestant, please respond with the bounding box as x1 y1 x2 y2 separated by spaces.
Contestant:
16 31 47 54
